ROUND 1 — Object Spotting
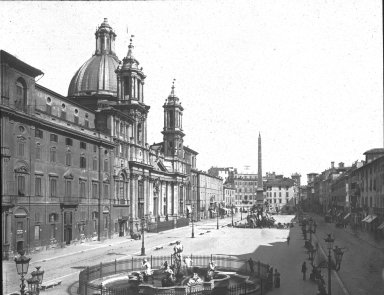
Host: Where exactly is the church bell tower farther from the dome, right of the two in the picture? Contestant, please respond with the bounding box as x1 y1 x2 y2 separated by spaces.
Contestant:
161 79 185 158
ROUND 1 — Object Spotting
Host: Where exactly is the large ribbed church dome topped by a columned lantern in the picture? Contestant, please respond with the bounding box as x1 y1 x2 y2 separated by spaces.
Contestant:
68 18 120 97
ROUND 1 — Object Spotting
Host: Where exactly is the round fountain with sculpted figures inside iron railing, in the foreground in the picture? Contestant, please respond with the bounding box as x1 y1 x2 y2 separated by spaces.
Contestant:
79 241 269 295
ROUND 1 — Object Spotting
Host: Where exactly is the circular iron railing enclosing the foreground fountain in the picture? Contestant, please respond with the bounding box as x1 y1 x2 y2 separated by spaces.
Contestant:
78 255 269 295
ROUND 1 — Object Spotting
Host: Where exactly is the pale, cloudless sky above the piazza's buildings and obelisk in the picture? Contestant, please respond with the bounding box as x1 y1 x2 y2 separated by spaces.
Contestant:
0 0 383 183
